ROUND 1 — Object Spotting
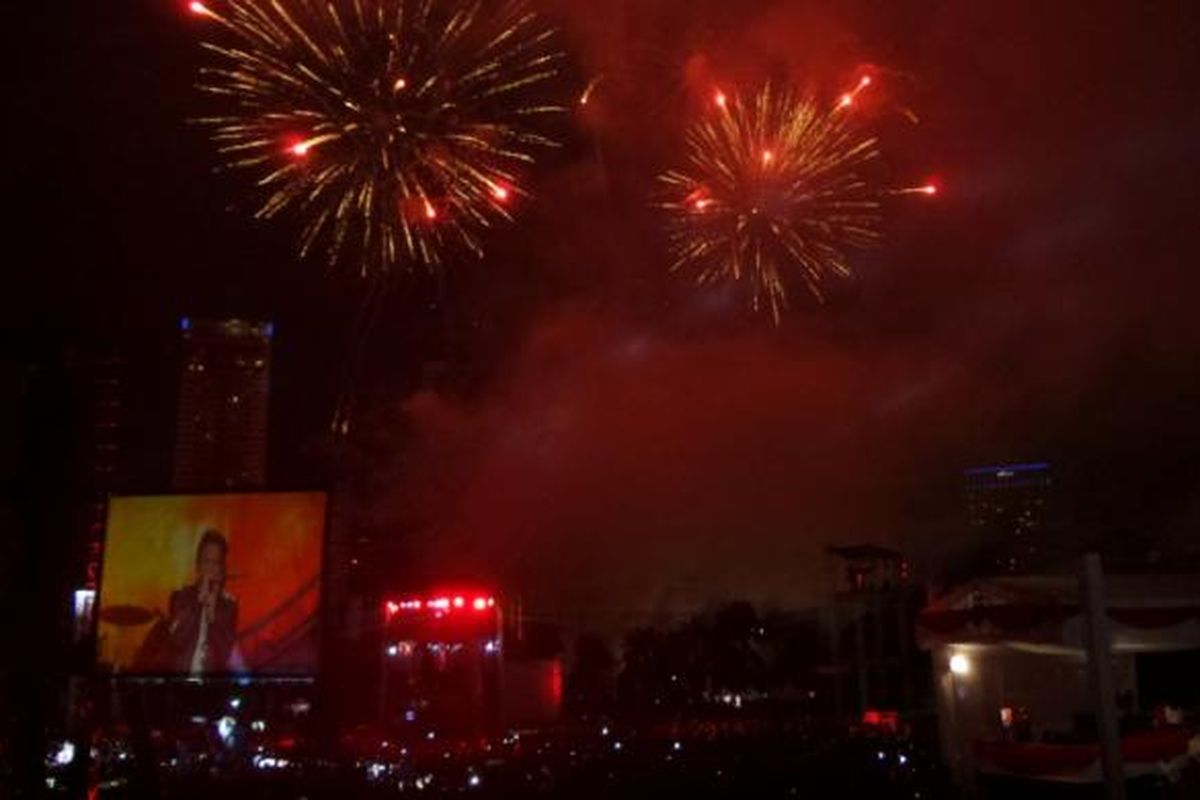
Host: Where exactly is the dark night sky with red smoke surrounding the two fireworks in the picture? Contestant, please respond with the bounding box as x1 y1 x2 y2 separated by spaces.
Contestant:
7 0 1200 623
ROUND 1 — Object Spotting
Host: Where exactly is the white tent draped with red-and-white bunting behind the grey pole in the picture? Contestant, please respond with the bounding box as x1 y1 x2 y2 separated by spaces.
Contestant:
917 575 1200 781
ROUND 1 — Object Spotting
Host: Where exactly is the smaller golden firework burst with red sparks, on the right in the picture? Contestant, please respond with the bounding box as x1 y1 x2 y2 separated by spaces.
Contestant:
659 78 936 323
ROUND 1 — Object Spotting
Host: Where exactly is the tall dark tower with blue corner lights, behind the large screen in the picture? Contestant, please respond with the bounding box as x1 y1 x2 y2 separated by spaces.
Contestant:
174 317 274 492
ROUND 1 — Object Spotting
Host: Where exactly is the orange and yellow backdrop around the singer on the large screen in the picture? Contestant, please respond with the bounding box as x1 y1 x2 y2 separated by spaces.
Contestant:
97 492 325 674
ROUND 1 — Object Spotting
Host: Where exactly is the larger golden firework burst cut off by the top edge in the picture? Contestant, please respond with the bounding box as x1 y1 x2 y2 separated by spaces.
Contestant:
191 0 563 275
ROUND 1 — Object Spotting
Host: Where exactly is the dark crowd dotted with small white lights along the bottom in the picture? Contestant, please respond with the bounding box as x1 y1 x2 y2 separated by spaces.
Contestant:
47 704 947 800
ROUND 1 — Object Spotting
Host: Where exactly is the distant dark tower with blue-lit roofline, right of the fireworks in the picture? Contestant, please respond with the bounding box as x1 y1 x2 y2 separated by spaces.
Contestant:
964 463 1054 573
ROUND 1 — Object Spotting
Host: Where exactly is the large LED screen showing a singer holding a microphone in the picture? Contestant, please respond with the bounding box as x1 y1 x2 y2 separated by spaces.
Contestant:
96 492 325 676
